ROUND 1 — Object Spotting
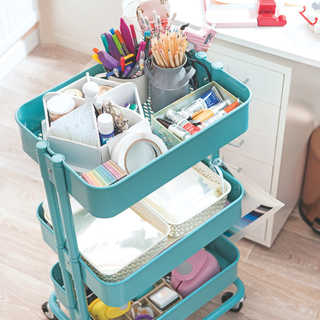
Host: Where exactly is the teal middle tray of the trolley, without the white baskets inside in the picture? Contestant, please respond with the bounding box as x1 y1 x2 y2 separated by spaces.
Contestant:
37 172 244 306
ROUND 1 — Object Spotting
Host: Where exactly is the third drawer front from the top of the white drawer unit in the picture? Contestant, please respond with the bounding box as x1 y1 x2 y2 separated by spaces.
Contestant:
223 129 276 165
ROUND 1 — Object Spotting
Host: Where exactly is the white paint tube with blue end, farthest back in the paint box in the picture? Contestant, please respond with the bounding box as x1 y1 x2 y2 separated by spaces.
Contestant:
180 87 223 119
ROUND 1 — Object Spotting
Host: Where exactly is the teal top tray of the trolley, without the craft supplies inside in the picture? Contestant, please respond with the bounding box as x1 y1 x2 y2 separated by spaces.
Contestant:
16 59 251 219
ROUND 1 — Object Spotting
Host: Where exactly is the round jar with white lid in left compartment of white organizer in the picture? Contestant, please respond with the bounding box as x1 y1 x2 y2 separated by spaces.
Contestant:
47 94 76 122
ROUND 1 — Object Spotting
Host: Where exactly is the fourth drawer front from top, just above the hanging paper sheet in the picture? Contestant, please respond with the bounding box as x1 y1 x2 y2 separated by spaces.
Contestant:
220 147 273 193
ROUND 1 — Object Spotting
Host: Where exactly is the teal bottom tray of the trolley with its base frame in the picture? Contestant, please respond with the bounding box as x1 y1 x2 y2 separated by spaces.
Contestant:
50 236 244 320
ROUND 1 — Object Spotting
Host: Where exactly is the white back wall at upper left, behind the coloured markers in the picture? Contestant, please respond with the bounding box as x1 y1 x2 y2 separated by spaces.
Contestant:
39 0 122 54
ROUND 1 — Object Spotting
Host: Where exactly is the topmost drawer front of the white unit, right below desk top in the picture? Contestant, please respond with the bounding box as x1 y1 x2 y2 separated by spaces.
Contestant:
208 51 284 106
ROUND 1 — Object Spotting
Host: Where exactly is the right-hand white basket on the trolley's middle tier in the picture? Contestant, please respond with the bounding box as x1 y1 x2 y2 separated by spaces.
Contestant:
141 162 231 238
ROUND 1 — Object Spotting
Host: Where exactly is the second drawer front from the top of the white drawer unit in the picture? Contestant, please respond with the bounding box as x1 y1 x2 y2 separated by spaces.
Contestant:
249 98 280 137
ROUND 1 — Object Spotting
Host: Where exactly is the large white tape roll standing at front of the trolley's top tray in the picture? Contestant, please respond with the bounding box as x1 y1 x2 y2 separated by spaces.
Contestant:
111 132 167 174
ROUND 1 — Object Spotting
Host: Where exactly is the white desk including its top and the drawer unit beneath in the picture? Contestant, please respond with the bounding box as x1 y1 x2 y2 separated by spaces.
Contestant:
173 0 320 246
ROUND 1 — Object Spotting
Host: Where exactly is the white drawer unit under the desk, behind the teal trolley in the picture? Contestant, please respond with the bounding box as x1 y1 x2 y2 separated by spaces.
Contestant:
208 38 301 247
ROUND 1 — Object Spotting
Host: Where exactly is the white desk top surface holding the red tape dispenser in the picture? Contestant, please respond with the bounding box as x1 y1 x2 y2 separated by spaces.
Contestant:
175 0 320 68
